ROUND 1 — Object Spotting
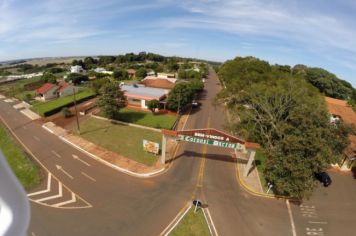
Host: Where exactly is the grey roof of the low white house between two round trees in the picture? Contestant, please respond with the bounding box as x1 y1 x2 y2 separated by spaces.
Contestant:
121 85 169 100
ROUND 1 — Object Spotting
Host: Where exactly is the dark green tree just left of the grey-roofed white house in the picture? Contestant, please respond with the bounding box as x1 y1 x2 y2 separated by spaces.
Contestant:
98 82 126 119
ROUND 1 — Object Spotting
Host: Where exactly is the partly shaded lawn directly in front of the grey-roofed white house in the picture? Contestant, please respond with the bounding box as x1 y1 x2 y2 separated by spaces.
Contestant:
108 108 177 129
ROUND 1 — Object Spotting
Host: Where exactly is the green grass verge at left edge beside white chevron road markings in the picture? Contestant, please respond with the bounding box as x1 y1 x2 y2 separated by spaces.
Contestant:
0 124 41 190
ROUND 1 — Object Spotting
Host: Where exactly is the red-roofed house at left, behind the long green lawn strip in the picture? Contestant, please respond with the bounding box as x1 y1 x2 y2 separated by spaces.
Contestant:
36 82 78 101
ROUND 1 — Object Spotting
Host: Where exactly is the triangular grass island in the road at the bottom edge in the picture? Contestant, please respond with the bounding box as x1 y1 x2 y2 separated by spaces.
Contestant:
169 206 210 236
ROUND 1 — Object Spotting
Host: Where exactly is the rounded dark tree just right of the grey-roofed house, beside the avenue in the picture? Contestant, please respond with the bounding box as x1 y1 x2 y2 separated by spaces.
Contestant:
167 83 194 111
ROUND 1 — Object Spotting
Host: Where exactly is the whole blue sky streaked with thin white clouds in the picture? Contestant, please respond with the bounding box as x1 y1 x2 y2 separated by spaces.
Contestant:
0 0 356 87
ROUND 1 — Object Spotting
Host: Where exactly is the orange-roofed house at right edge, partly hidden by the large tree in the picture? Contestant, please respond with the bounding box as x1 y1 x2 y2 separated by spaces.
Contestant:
325 97 356 169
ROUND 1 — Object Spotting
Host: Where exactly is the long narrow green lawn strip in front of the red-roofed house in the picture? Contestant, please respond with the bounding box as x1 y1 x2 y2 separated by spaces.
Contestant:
31 90 94 116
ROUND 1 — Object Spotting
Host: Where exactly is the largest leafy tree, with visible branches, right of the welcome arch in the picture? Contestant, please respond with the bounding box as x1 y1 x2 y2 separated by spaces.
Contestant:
220 74 347 199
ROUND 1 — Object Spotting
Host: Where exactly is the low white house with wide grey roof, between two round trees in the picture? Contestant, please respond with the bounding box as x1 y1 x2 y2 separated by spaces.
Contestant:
121 84 169 109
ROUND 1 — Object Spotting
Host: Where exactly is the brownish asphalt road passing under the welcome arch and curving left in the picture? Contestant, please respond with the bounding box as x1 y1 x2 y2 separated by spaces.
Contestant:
0 69 355 236
